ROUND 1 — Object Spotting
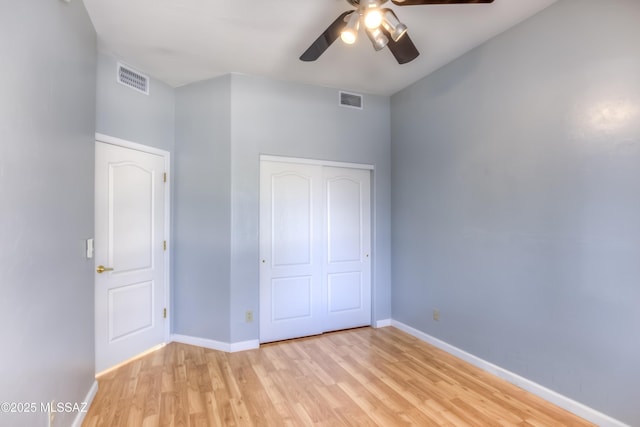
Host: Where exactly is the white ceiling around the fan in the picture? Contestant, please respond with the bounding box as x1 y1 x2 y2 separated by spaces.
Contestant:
83 0 556 95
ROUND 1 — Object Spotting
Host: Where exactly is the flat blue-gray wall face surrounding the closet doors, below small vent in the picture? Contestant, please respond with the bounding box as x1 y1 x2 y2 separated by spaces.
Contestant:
230 74 391 342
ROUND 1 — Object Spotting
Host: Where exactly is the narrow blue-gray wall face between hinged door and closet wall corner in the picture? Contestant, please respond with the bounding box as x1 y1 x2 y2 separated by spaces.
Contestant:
173 76 231 342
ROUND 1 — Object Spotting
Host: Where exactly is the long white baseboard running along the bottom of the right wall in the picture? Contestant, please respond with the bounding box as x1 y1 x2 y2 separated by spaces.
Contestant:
391 320 629 427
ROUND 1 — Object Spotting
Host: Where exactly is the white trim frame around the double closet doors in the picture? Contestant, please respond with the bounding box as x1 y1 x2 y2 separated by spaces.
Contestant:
258 154 376 342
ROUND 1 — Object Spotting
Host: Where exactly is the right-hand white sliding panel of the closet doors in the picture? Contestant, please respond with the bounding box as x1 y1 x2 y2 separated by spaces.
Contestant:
323 167 371 331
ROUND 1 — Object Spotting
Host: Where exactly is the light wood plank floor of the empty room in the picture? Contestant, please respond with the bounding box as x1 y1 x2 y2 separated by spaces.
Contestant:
83 327 592 427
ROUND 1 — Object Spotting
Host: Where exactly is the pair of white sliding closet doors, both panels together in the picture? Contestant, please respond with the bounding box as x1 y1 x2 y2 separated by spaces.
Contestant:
260 161 371 342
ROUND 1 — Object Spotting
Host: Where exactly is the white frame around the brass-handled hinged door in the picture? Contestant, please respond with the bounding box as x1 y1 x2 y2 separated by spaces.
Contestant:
94 132 172 343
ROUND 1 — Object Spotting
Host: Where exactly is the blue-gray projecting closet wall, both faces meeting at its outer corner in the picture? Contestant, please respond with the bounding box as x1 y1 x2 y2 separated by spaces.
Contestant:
174 74 391 343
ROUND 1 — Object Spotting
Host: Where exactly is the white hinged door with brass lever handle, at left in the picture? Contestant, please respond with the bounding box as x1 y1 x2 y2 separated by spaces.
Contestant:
94 142 166 372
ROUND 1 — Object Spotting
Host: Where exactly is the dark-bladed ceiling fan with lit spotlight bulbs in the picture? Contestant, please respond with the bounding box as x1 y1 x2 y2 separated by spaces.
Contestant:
300 0 493 64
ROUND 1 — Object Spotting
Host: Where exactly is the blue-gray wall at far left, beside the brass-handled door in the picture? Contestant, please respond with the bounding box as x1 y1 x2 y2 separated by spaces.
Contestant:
0 1 96 426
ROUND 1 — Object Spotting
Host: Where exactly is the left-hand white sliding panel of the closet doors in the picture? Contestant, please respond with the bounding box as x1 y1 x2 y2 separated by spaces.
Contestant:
260 161 324 342
